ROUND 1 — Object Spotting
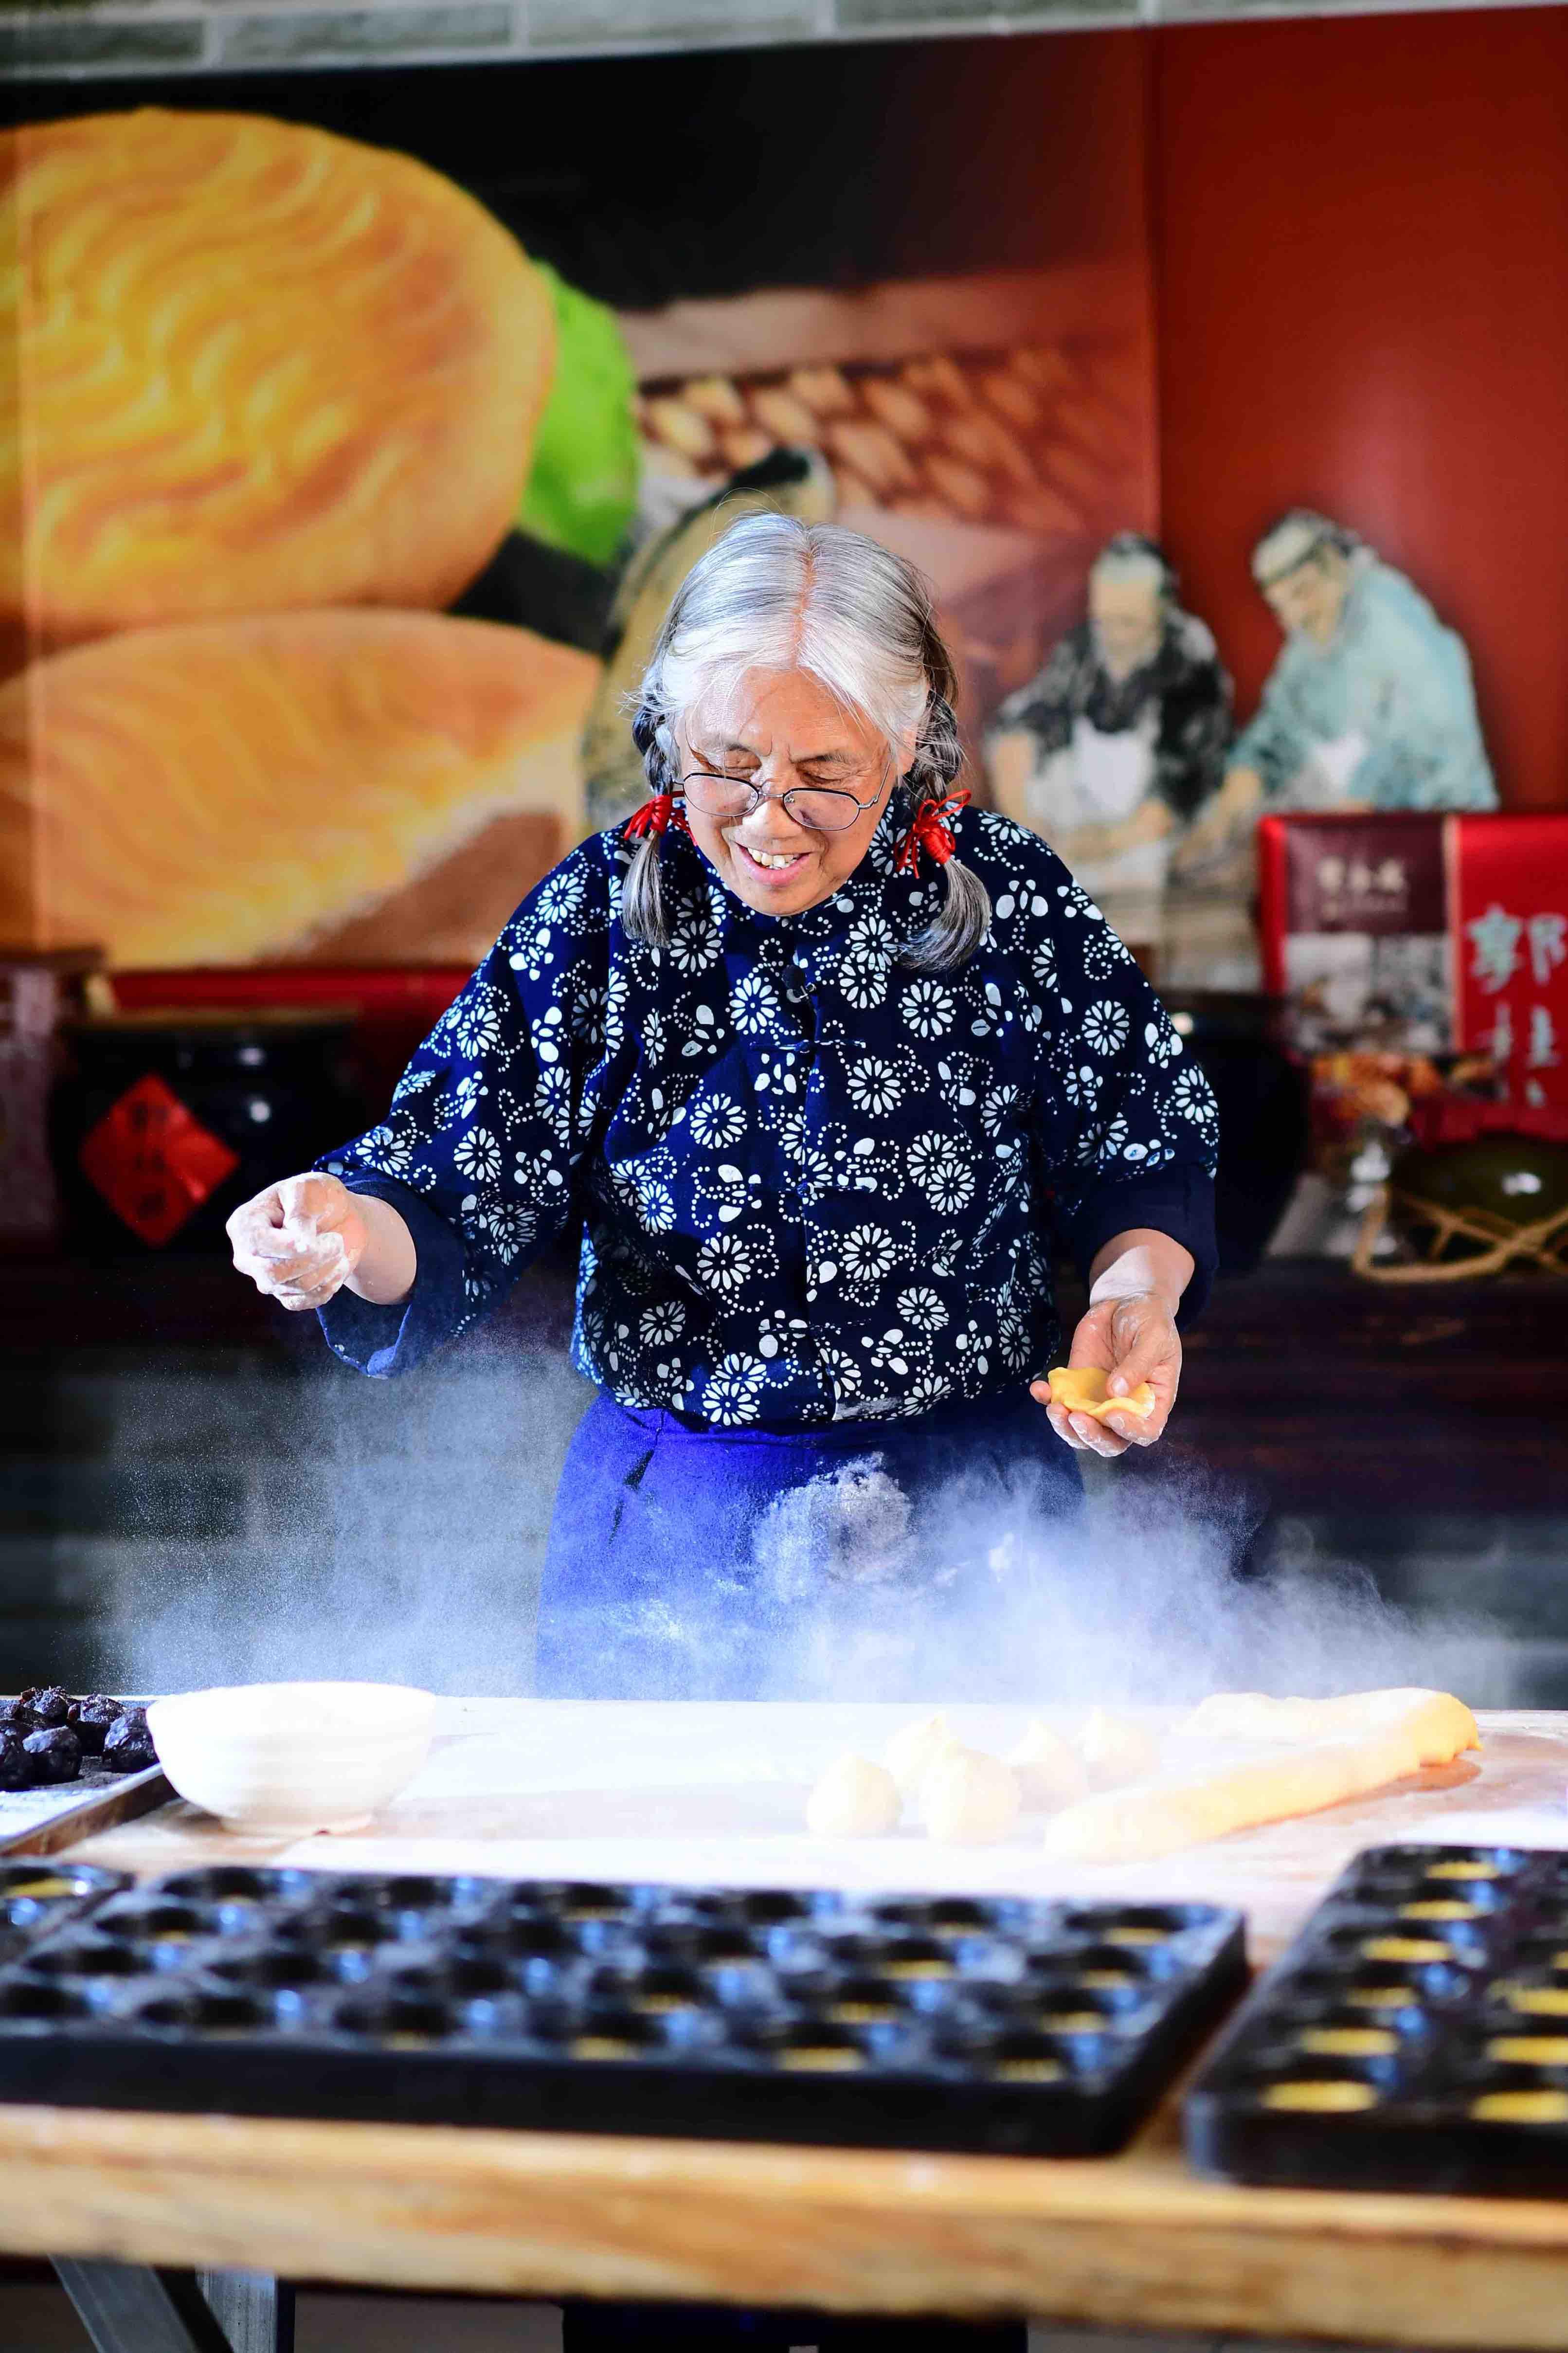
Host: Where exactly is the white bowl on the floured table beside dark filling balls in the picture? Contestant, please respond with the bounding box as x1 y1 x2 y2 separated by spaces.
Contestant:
146 1683 435 1838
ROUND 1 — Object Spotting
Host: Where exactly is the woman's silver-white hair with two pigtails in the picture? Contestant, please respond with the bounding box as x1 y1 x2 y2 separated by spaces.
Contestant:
622 513 991 972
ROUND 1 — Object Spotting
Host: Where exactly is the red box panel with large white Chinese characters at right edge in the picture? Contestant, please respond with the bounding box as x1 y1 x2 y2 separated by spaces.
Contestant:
1448 816 1568 1106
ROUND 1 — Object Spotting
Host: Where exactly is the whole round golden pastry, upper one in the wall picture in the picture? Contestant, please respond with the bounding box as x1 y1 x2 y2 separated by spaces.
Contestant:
0 106 556 654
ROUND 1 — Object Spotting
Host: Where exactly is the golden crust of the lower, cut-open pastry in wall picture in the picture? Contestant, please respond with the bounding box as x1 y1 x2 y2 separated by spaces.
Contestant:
0 612 598 967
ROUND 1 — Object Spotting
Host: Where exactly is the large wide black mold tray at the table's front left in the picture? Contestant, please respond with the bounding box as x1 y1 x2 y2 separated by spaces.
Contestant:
0 1868 1245 2155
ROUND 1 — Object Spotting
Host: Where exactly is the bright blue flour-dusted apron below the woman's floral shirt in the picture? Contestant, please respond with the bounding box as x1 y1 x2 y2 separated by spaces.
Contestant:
535 1388 1083 1699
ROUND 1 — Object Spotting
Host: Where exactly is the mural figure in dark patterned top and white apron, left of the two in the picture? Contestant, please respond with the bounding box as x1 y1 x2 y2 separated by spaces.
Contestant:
987 532 1231 939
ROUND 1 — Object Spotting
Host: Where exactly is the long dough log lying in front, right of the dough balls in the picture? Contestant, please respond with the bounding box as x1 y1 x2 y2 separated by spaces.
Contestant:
1045 1729 1422 1864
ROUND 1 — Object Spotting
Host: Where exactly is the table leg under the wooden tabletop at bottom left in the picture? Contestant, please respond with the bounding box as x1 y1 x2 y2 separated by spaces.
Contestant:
54 2257 294 2353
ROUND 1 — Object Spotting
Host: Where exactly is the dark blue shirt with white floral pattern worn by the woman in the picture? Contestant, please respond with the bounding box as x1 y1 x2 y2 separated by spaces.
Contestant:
320 810 1217 1426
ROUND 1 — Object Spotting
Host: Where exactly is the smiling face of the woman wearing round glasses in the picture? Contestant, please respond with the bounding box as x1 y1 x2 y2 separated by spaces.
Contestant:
676 670 914 915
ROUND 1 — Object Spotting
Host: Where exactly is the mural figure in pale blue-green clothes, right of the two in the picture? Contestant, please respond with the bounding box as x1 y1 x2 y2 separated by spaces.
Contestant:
1180 508 1497 868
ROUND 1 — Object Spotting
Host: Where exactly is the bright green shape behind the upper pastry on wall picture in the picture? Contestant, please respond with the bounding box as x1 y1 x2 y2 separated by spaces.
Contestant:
518 261 638 565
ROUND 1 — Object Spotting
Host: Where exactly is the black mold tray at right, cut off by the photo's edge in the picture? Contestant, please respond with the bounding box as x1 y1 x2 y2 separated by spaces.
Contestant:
1184 1845 1568 2198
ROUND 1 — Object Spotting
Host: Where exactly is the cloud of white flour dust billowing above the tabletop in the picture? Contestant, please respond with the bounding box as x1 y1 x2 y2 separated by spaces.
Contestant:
94 1334 1509 1706
